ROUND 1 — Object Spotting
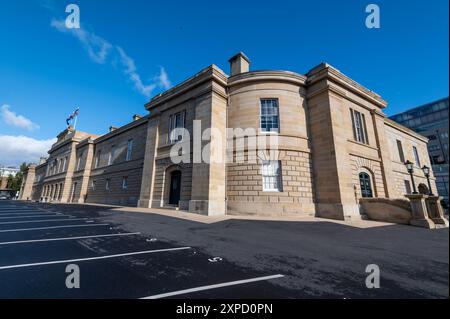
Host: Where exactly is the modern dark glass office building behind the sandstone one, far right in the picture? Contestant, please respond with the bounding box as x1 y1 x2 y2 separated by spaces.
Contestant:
391 97 449 208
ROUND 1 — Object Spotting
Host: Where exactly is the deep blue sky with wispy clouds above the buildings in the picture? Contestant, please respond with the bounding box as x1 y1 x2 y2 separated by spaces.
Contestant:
0 0 449 164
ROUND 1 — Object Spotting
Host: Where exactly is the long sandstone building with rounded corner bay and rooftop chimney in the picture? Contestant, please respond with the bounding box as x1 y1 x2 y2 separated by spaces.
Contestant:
21 53 436 219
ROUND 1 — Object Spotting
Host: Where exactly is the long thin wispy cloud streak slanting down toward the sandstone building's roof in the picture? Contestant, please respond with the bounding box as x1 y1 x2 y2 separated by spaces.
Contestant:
51 19 172 98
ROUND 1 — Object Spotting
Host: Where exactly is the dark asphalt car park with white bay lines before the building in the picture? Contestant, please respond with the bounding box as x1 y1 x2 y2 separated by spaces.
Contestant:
0 201 449 299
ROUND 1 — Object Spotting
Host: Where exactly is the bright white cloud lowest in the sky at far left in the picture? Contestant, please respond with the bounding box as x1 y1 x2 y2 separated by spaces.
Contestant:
0 135 56 166
